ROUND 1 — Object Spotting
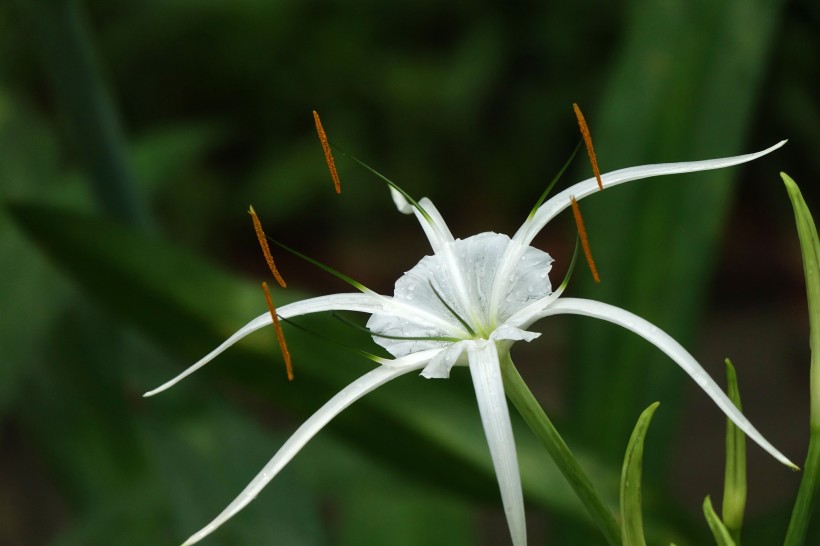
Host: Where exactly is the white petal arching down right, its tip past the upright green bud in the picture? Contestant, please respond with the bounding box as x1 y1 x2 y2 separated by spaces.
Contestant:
541 298 797 468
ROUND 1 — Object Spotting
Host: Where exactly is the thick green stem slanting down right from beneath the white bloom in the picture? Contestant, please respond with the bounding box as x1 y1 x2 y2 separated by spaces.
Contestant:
501 354 621 546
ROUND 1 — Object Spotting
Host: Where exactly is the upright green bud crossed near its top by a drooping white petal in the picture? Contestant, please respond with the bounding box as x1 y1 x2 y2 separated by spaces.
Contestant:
720 358 746 544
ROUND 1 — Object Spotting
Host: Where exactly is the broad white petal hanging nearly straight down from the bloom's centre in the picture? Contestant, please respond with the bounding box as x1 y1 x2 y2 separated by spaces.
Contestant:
467 341 527 546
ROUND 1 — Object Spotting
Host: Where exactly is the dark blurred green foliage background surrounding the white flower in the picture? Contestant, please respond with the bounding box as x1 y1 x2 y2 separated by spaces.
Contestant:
0 0 820 546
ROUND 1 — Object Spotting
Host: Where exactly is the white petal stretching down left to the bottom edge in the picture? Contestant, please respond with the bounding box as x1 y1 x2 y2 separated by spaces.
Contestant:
183 357 424 546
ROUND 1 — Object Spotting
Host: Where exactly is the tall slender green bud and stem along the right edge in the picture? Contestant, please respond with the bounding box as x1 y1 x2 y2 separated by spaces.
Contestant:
780 173 820 546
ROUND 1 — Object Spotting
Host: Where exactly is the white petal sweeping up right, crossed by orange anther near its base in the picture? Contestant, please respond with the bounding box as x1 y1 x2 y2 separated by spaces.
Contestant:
513 140 786 245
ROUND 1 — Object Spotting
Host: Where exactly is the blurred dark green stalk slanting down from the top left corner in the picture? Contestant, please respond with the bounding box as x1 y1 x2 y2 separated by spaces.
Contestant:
18 0 150 227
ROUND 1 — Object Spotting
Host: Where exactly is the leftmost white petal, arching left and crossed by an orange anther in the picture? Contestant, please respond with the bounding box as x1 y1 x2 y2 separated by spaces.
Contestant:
143 293 384 397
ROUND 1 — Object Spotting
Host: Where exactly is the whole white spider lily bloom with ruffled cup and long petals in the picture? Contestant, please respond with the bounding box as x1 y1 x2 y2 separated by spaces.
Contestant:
146 141 794 546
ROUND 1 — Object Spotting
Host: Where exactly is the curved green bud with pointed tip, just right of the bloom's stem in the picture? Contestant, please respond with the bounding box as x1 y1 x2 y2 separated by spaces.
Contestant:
621 402 660 546
